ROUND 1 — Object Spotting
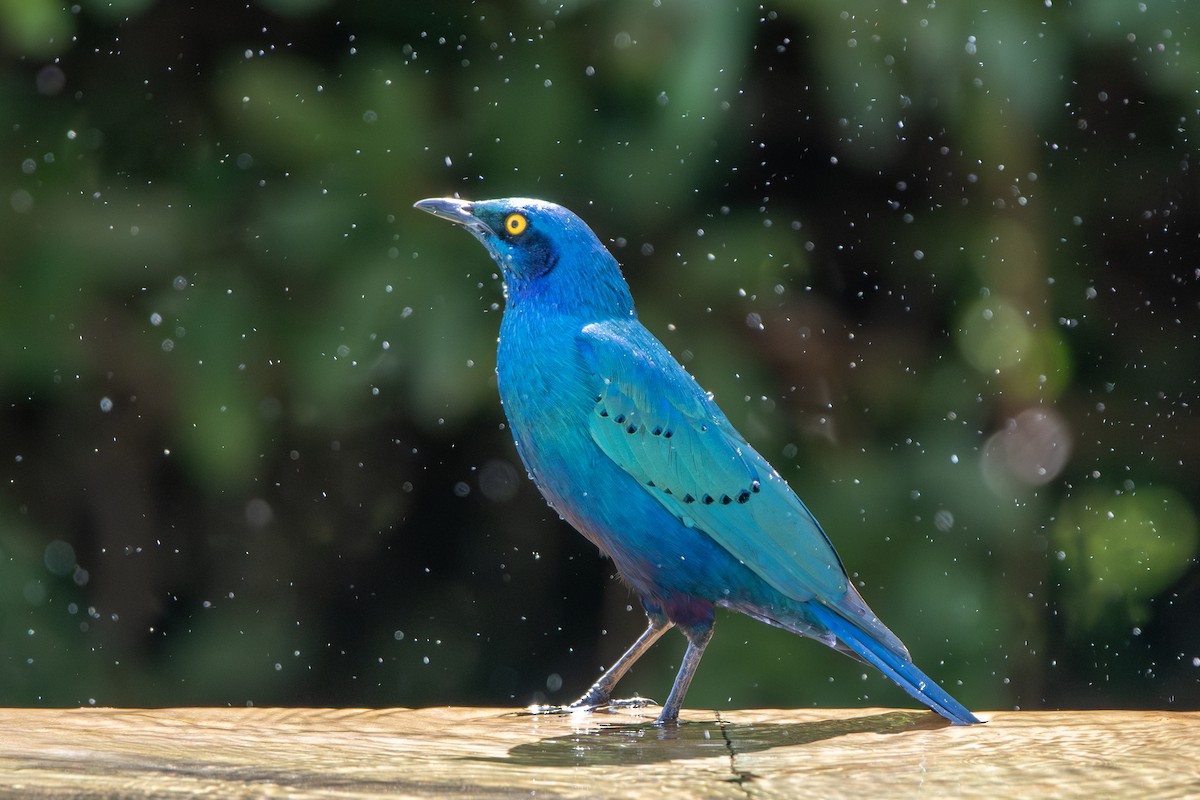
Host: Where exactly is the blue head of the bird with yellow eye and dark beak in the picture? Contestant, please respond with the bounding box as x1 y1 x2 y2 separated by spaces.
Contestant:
414 198 632 314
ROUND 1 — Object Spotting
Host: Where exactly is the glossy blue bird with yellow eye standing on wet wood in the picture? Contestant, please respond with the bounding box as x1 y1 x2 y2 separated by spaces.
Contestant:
414 198 979 724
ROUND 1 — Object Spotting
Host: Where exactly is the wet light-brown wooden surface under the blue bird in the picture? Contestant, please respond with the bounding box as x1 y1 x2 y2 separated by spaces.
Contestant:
0 708 1200 799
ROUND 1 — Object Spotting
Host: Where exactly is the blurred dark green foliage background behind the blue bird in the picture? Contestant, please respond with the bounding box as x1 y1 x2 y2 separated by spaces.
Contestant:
0 0 1200 709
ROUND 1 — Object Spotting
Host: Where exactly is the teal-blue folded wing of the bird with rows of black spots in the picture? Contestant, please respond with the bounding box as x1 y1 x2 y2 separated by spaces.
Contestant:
578 320 859 606
